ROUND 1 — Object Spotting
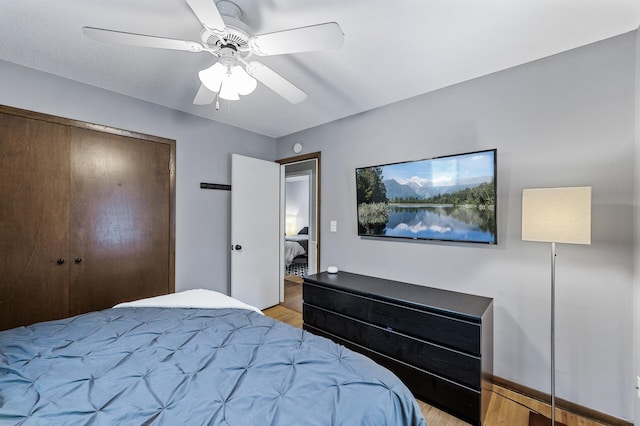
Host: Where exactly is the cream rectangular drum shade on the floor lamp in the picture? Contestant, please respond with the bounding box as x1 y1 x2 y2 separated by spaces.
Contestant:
522 186 591 244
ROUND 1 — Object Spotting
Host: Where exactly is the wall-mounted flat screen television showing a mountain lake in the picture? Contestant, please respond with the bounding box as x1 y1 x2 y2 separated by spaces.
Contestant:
356 149 498 244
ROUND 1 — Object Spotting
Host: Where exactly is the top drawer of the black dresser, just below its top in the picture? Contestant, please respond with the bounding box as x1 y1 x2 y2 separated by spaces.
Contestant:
303 283 480 355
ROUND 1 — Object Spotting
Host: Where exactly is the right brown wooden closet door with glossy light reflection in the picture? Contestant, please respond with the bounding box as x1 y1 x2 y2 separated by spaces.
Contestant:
70 129 170 315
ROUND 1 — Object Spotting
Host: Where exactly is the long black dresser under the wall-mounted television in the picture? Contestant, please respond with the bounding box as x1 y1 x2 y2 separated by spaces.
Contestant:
302 271 493 425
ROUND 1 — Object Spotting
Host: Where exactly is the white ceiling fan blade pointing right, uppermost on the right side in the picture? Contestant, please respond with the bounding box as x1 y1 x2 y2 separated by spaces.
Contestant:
249 22 344 56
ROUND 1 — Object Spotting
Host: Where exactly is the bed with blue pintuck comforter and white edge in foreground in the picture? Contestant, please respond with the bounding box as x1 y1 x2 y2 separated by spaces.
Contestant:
0 290 426 426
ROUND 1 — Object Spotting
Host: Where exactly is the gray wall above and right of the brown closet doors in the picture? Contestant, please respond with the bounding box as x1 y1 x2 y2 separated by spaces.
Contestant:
0 61 275 294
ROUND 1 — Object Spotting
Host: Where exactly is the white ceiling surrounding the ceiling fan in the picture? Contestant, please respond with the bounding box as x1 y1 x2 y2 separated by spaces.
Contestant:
0 0 640 137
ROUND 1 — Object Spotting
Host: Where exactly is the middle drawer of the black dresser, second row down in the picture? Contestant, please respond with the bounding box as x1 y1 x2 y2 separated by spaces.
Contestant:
303 304 481 389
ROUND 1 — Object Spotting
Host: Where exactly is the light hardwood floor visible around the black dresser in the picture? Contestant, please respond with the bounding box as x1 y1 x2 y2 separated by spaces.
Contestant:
264 305 606 426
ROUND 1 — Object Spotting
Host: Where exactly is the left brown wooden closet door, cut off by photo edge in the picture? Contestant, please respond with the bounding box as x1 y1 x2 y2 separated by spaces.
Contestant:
0 113 70 330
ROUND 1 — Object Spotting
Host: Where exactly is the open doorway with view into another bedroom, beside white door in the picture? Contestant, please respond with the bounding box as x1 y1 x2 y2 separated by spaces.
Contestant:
278 152 320 311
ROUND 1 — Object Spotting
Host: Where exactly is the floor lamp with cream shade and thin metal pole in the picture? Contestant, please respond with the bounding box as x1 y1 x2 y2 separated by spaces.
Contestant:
522 186 591 426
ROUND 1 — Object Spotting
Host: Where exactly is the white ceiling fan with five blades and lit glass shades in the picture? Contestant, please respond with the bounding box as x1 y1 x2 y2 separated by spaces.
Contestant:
82 0 344 108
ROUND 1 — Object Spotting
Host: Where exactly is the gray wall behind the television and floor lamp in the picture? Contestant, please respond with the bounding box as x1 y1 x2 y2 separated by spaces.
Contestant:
277 33 636 420
